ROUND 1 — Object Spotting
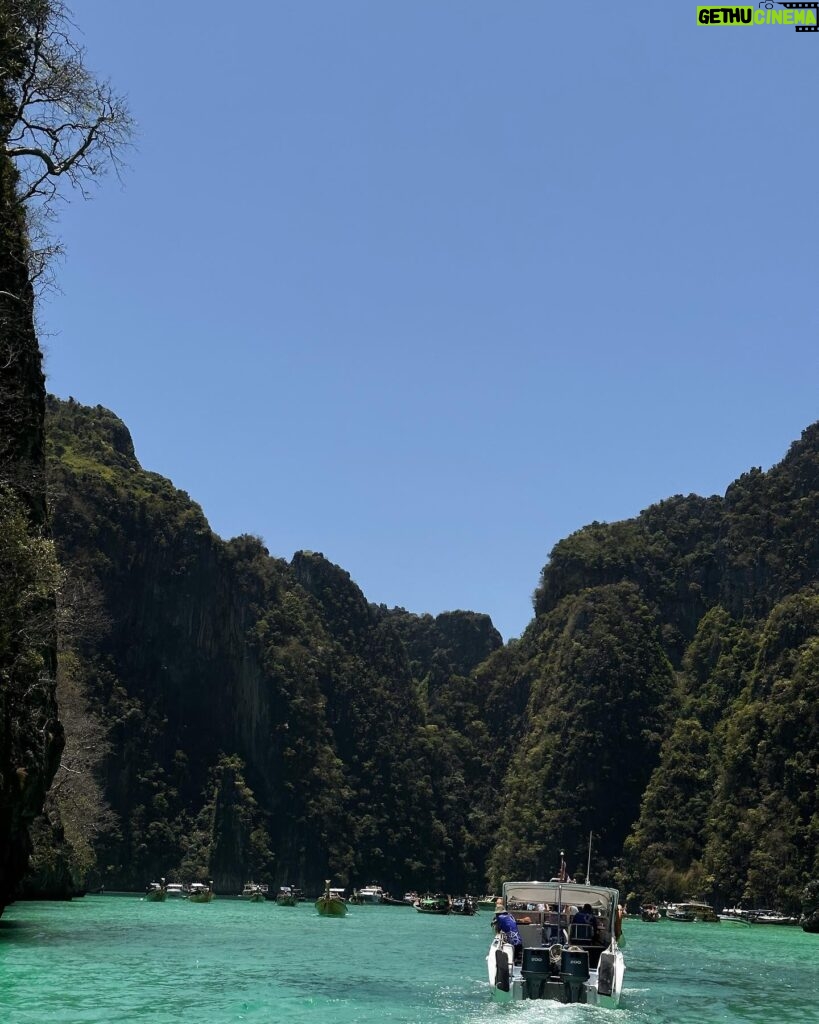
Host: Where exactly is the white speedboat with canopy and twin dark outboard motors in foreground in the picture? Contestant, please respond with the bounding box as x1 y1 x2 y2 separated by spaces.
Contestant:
486 879 626 1007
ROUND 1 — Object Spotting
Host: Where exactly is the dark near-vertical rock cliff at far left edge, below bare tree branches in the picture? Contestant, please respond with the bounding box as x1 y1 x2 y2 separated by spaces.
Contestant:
0 158 62 912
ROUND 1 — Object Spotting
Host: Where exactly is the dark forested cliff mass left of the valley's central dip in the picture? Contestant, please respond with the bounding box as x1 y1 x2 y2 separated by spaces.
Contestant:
44 399 501 889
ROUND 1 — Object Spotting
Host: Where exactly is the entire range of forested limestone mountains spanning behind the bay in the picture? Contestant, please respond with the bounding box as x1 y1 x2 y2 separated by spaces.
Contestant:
35 387 819 904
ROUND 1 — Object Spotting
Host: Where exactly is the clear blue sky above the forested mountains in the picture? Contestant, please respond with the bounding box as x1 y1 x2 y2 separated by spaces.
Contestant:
41 0 819 637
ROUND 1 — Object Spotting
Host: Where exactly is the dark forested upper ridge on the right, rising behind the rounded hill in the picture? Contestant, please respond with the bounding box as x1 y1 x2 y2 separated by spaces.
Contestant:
535 424 819 647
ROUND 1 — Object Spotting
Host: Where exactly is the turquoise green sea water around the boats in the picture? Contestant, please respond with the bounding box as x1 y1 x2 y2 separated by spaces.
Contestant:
0 895 819 1024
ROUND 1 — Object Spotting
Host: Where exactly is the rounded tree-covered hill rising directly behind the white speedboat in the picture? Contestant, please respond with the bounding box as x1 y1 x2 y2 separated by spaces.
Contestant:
489 584 675 885
